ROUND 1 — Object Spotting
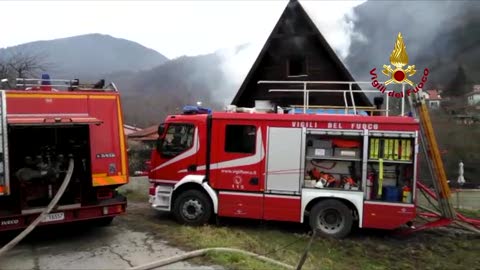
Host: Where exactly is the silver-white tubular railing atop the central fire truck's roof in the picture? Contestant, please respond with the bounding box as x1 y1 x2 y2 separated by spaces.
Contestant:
258 80 405 116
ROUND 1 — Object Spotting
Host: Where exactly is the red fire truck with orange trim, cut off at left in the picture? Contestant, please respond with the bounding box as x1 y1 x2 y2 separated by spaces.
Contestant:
0 76 128 231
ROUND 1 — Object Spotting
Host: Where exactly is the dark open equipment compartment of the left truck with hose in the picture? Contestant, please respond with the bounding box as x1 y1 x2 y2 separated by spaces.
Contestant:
9 125 91 212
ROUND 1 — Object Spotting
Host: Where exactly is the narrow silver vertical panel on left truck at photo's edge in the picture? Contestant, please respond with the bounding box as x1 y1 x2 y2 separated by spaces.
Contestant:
0 90 10 196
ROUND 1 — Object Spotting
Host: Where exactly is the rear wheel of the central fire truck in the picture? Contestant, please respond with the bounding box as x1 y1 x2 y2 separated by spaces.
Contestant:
310 200 353 238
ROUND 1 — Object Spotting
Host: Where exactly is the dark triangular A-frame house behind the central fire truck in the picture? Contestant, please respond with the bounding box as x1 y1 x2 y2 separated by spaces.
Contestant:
232 0 372 107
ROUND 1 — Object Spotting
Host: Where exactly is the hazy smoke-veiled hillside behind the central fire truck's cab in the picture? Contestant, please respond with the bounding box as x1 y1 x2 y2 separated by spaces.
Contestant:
106 54 229 126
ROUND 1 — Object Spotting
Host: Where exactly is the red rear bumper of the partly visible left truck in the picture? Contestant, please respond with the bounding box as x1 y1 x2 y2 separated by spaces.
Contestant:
0 195 127 232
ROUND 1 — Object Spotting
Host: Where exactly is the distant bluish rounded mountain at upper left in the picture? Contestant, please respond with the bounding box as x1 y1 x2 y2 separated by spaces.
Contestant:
0 34 168 80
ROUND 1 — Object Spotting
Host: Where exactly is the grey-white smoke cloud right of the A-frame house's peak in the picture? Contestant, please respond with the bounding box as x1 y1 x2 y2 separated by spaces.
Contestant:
345 1 474 80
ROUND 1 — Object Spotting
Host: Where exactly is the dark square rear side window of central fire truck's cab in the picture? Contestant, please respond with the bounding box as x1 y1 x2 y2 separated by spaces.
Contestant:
225 125 256 154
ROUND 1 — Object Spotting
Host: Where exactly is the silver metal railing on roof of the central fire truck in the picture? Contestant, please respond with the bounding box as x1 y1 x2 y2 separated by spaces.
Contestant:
258 80 405 116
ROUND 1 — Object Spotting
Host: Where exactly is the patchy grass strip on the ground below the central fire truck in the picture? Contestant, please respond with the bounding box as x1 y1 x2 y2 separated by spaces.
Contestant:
122 188 480 270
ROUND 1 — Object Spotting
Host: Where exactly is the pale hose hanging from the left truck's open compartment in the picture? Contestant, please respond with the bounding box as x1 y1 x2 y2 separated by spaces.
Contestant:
0 158 74 257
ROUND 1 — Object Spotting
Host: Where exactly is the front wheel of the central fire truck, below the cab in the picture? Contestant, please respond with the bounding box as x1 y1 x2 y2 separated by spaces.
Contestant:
173 190 212 226
